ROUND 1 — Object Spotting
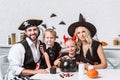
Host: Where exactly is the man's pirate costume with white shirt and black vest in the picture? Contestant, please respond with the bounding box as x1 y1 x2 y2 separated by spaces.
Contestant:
5 38 42 80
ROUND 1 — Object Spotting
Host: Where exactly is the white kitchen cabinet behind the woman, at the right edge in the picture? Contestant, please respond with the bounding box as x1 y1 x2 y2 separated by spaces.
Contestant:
103 46 120 69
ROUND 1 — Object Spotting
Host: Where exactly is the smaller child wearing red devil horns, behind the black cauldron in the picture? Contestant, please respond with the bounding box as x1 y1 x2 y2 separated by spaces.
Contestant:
54 36 78 67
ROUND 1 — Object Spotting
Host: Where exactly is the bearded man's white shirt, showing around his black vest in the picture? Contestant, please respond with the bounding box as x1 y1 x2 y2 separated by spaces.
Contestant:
4 38 40 79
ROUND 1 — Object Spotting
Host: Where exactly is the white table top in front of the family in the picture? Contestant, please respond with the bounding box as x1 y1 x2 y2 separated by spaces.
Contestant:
31 69 120 80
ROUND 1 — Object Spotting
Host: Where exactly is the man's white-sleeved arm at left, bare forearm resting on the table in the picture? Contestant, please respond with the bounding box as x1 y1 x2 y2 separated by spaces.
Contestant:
8 44 47 76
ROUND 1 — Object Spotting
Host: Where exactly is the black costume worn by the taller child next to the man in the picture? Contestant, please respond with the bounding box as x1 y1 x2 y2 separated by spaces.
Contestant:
41 42 61 68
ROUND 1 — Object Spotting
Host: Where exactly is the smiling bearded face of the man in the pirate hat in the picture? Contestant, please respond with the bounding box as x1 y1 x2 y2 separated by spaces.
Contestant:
25 26 39 41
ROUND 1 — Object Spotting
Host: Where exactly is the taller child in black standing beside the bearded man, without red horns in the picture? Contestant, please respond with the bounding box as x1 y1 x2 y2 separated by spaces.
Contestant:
40 28 61 68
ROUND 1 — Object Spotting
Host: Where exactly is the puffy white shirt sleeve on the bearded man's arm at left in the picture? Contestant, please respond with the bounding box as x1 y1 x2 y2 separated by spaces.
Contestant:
8 43 25 75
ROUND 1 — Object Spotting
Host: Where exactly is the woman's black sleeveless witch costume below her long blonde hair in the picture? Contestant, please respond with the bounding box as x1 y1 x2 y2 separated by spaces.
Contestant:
79 40 101 65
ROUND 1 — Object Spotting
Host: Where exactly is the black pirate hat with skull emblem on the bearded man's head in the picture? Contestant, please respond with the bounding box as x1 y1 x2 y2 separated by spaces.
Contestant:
18 19 43 30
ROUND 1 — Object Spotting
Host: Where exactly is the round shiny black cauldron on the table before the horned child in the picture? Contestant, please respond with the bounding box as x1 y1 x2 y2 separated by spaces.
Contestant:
60 59 77 72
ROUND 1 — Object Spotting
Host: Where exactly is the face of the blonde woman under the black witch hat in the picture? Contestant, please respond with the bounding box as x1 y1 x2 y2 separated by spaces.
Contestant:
75 27 88 41
